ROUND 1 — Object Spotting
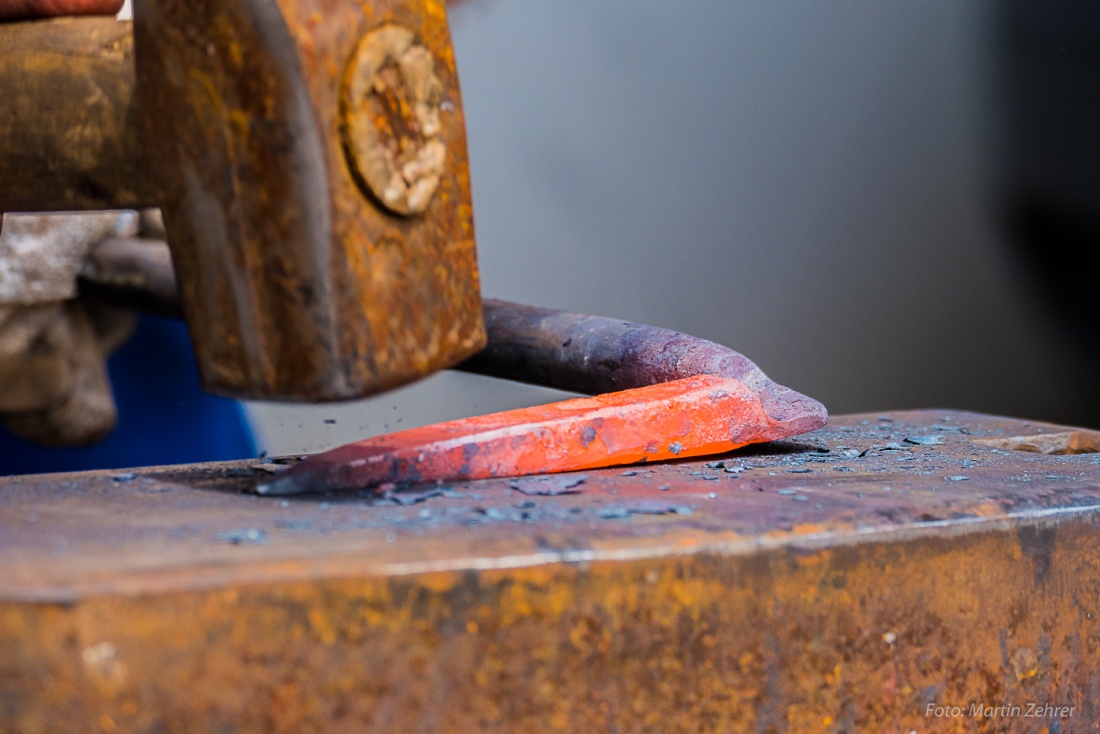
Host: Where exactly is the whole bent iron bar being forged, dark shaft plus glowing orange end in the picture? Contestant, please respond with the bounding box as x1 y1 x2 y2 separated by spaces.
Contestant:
81 240 827 495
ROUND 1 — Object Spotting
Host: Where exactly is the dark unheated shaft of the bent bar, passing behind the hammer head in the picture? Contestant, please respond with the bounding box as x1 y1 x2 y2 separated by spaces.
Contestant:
80 239 827 432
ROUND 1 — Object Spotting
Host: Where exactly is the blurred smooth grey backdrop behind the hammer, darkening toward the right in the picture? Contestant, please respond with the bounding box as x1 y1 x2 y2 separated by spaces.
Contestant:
250 0 1100 453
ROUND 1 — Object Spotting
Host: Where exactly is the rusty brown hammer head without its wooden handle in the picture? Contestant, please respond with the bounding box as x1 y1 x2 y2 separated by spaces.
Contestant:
134 0 484 401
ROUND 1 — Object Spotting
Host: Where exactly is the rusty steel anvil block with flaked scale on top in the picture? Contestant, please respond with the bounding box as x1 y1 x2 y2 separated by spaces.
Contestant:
0 412 1100 732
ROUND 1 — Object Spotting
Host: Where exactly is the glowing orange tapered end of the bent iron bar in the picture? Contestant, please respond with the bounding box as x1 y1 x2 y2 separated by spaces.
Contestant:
259 375 822 494
